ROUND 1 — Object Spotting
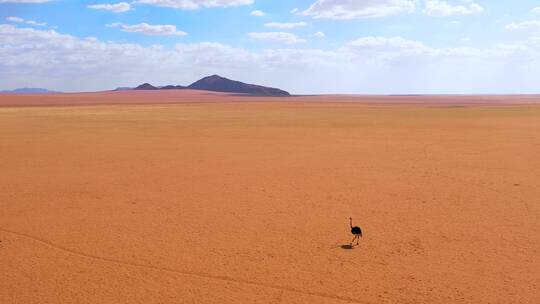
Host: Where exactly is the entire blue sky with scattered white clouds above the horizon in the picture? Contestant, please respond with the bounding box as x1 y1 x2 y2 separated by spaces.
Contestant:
0 0 540 94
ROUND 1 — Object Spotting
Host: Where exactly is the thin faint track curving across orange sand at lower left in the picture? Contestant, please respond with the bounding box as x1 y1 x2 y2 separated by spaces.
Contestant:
0 228 366 304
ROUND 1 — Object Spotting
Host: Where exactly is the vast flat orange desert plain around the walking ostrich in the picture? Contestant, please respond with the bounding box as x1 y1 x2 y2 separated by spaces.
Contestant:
0 92 540 304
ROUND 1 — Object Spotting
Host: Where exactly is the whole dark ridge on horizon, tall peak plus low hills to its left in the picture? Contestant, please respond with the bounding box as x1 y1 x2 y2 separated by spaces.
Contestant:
133 75 291 96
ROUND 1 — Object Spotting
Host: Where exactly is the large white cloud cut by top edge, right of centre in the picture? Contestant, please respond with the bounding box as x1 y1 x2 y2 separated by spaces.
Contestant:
302 0 418 19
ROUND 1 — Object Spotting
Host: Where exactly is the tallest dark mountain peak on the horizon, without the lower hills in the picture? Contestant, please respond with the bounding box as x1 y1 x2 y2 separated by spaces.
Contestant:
187 75 290 96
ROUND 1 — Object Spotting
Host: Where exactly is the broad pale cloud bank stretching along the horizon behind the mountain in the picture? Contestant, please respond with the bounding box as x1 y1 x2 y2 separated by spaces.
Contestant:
0 24 540 94
